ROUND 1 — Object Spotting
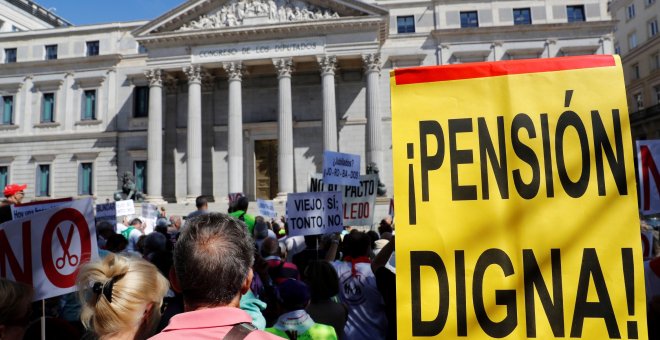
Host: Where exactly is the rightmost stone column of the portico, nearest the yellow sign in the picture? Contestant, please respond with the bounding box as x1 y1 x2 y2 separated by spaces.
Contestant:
362 54 383 174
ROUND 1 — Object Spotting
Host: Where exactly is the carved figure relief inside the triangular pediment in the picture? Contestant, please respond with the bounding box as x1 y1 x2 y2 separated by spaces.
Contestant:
179 0 339 31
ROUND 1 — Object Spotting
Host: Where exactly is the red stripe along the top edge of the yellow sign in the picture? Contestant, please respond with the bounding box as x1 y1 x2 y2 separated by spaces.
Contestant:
394 55 616 85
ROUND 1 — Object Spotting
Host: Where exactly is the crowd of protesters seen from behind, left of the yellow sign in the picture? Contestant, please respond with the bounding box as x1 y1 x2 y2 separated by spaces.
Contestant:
0 193 396 340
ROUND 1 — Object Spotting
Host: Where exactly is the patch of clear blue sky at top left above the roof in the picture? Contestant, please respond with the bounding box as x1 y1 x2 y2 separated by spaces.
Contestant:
36 0 185 25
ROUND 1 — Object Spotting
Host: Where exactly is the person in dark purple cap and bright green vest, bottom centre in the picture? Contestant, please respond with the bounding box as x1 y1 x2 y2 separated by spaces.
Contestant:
266 279 337 340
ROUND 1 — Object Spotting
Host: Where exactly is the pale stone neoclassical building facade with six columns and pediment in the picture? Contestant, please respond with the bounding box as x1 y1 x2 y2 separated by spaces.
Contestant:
0 0 614 203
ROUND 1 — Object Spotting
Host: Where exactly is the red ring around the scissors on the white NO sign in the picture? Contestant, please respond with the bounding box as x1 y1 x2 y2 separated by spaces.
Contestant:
41 208 92 288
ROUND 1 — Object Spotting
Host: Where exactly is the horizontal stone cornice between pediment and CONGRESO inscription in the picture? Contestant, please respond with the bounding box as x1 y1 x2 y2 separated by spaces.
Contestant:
136 17 389 47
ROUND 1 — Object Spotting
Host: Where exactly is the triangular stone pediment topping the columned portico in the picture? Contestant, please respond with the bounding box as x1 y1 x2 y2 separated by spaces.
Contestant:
134 0 388 38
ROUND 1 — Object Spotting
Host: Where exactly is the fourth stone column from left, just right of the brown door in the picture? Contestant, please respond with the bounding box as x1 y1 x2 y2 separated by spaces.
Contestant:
273 58 294 199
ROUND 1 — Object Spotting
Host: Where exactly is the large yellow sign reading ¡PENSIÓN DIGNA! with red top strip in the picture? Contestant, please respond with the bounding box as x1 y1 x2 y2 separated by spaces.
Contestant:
390 56 647 339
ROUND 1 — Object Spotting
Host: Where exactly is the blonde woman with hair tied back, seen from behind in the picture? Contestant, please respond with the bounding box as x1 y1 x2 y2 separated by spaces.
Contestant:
77 254 169 339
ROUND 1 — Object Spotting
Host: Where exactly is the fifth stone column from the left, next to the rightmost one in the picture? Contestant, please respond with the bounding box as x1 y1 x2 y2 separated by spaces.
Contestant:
318 56 337 152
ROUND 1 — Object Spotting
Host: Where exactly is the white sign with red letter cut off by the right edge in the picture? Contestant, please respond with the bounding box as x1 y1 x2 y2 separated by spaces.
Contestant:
637 140 660 215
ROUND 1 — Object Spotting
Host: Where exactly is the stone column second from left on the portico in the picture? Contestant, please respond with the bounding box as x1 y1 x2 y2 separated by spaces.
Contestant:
183 65 202 201
